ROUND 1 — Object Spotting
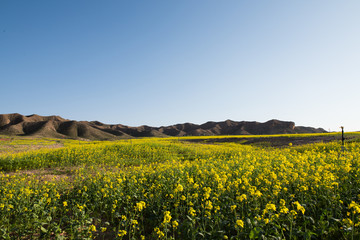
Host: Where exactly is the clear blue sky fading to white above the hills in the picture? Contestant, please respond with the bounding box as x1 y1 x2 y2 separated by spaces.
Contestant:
0 0 360 131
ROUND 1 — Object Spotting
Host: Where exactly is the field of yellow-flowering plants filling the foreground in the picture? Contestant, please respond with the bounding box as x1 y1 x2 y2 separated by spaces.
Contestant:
0 138 360 239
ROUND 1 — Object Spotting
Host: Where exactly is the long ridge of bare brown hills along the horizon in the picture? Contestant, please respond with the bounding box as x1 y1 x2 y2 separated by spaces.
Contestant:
0 113 326 140
